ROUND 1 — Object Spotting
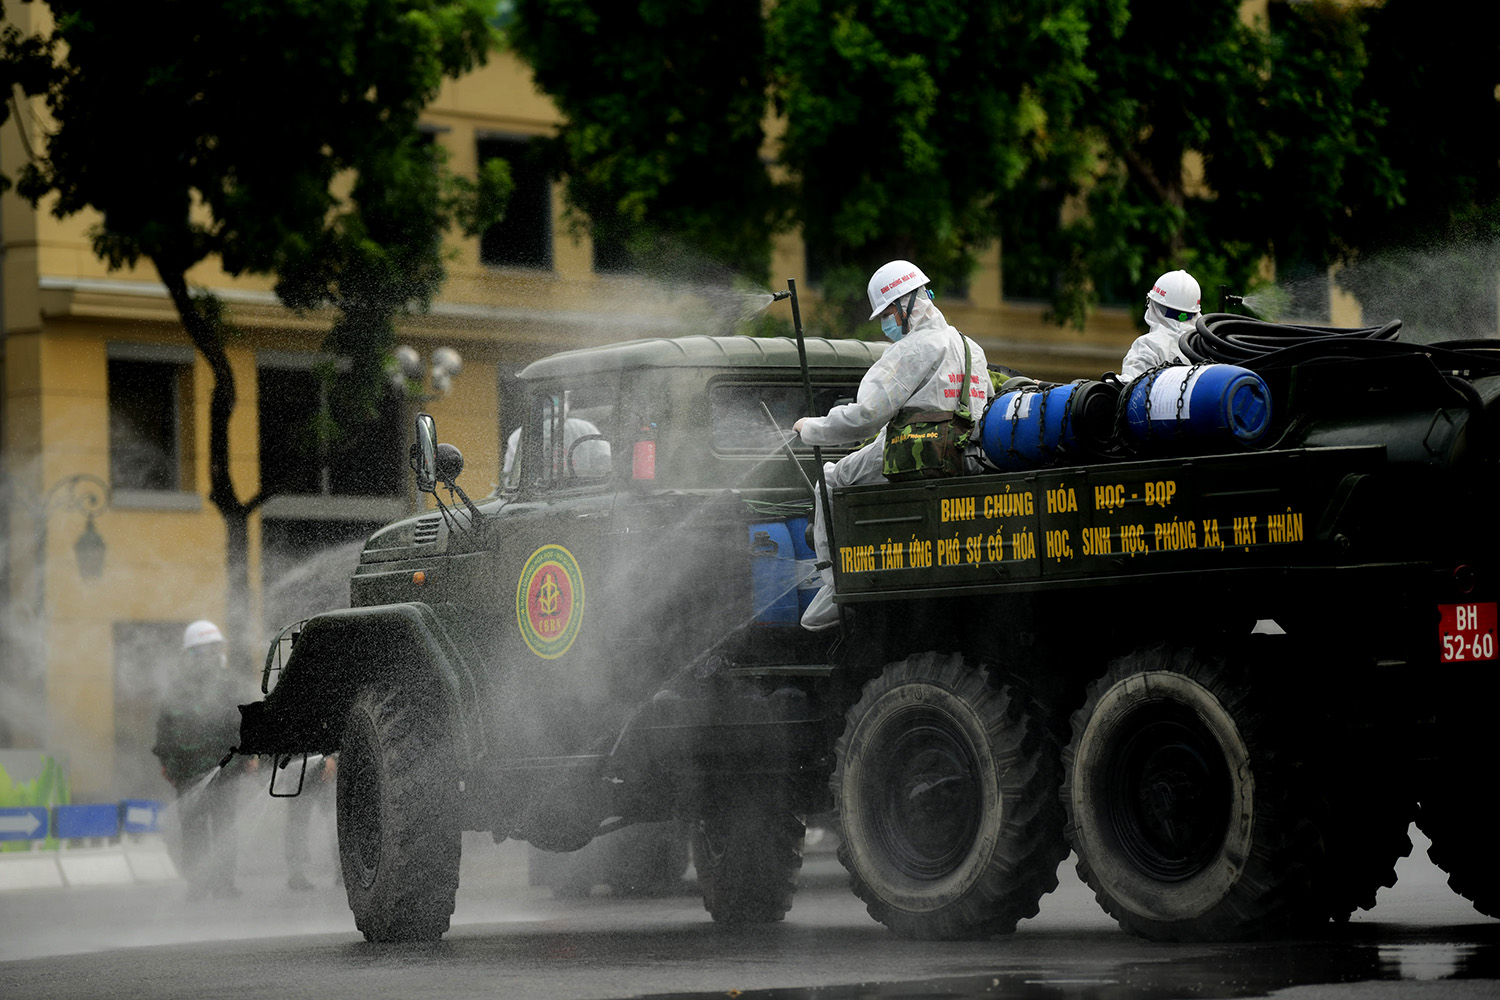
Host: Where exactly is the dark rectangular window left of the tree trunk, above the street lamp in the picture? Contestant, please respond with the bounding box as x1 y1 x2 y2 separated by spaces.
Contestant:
108 343 194 492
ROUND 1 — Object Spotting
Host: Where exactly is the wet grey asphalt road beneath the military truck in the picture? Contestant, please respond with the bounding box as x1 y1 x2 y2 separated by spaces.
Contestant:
0 831 1500 1000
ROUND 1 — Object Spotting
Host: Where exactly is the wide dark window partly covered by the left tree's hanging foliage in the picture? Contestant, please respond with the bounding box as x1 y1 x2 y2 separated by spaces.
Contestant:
257 352 405 496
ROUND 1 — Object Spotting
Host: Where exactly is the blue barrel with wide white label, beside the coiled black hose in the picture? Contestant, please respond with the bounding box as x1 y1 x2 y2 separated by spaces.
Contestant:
1125 364 1271 444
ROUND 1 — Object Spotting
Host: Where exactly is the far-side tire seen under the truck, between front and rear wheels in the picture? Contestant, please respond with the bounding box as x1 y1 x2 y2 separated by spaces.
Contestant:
693 789 807 924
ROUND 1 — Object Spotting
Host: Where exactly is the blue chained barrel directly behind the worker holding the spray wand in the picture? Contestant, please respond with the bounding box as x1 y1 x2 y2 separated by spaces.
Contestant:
980 379 1119 471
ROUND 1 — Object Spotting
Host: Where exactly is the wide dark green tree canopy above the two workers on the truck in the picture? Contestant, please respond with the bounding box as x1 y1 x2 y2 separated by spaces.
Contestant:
509 0 1500 335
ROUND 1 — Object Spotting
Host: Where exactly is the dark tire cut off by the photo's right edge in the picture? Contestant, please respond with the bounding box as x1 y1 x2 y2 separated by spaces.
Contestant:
1416 767 1500 918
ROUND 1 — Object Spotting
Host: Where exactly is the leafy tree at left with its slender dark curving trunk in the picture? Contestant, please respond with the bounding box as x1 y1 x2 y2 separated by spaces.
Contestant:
0 0 507 659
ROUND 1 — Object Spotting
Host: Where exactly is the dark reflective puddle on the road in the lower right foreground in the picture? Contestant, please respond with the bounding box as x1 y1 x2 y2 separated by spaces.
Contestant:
641 927 1500 1000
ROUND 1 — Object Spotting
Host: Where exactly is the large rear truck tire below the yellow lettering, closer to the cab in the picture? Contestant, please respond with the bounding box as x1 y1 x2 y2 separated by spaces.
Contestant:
833 652 1068 940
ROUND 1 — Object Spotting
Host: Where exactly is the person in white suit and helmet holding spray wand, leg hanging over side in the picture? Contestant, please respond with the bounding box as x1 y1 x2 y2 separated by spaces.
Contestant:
795 261 990 631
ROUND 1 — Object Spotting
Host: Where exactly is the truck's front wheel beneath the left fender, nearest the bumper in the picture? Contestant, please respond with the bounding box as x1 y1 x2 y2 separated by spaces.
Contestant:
338 687 461 942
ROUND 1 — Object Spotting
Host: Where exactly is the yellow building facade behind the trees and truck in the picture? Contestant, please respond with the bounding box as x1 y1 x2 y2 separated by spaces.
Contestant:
0 39 1218 801
